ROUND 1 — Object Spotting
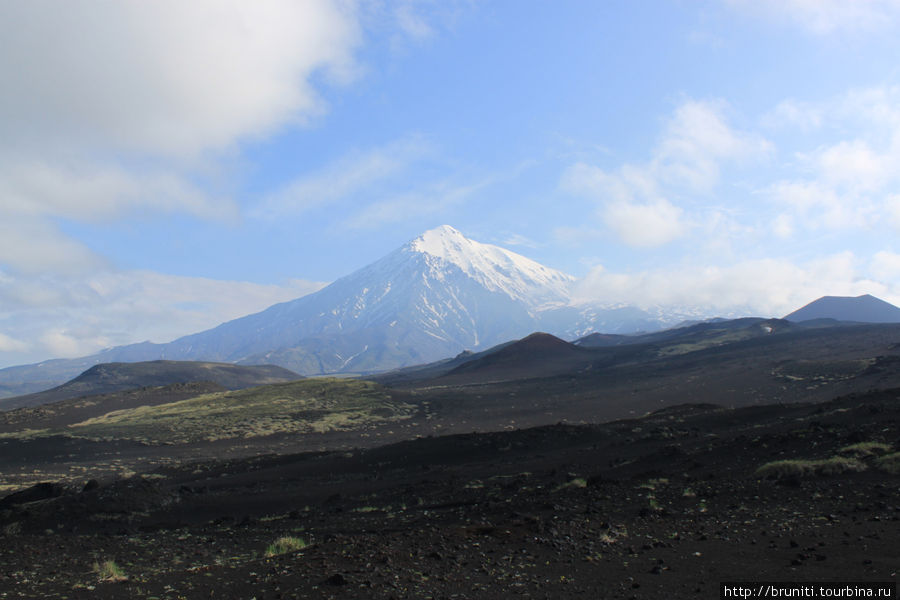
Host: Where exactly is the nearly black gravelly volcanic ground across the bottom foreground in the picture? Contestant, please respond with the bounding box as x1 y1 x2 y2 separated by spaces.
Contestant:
0 390 900 599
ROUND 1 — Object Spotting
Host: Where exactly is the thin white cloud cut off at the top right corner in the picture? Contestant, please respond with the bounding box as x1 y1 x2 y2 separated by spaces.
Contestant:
727 0 900 35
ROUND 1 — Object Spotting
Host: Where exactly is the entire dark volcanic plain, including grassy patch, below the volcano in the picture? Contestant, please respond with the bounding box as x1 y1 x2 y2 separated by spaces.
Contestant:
0 320 900 599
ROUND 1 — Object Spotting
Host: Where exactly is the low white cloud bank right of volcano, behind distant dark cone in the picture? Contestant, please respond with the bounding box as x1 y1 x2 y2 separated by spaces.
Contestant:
577 253 900 317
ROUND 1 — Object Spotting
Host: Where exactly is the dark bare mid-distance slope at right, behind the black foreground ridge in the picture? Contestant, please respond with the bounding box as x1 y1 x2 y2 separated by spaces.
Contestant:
392 322 900 424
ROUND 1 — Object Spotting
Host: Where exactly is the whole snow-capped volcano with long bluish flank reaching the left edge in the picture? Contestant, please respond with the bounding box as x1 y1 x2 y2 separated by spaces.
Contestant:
0 225 688 393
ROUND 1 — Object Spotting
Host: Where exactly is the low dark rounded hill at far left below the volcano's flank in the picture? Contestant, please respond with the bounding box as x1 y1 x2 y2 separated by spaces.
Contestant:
0 360 301 410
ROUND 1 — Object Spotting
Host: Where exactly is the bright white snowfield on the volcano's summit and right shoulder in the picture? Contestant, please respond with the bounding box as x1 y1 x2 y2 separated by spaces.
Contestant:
404 225 574 306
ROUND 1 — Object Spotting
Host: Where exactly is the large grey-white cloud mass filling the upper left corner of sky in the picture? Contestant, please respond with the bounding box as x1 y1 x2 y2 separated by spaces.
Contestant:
0 0 361 272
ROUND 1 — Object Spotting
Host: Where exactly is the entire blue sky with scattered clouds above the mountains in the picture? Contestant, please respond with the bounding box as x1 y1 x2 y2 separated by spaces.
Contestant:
0 0 900 367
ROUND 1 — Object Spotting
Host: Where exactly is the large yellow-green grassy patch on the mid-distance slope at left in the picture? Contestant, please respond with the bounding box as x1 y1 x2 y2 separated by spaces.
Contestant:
68 378 416 444
